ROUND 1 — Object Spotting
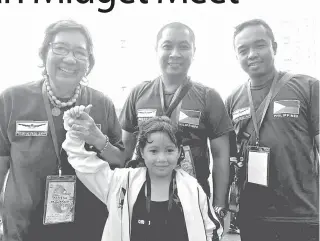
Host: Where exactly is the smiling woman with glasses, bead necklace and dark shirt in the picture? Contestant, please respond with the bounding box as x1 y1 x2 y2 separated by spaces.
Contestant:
0 20 123 241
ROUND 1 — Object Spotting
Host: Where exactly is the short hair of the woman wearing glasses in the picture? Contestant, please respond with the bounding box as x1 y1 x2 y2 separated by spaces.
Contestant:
39 20 95 75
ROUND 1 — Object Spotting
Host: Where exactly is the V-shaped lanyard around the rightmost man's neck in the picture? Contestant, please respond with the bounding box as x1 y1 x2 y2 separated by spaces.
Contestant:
247 73 279 146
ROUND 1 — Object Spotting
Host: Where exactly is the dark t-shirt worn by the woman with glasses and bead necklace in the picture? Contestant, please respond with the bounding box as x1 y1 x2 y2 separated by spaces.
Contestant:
0 81 123 241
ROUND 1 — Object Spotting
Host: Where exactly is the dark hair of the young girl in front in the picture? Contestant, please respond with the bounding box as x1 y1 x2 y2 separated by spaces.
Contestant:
131 116 184 167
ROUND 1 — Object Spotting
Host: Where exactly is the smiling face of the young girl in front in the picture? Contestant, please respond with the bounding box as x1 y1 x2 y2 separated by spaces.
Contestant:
140 132 180 178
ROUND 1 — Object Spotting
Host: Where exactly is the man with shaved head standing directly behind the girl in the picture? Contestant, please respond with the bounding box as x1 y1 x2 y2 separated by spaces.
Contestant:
119 23 233 217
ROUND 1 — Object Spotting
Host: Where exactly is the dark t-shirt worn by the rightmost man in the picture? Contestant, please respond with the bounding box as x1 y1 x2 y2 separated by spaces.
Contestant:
226 73 319 223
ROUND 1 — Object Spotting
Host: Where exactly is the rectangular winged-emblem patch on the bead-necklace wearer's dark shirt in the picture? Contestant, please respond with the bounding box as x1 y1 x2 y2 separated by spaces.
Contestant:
16 121 48 136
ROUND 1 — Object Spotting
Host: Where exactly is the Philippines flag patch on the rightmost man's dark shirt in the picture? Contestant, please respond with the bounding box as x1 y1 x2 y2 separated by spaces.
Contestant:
273 100 300 118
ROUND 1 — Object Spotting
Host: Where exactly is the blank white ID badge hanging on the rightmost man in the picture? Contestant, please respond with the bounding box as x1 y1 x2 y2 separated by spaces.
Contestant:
247 146 270 187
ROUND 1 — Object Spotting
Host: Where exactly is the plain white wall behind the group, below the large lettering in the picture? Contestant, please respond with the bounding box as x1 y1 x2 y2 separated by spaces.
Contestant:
0 0 320 108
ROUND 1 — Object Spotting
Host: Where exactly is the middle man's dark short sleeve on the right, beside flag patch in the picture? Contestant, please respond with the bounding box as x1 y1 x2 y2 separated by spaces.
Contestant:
206 88 233 140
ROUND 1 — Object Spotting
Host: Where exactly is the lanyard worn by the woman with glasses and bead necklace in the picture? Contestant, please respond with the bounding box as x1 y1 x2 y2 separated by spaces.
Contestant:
42 82 81 176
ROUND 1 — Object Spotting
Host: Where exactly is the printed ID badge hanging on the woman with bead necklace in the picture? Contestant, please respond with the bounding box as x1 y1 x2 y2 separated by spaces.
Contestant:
43 175 76 225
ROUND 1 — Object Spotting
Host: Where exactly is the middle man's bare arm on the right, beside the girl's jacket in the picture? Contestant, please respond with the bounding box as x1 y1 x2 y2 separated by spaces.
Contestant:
210 134 230 207
